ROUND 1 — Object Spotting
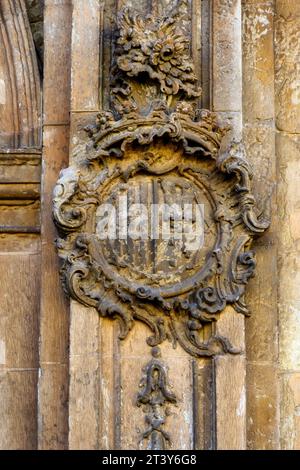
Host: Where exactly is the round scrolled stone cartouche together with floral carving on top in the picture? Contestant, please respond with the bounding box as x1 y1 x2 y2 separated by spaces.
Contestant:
53 2 269 357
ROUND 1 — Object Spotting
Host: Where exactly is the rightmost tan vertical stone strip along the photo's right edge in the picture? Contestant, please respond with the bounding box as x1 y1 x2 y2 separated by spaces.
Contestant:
275 0 300 449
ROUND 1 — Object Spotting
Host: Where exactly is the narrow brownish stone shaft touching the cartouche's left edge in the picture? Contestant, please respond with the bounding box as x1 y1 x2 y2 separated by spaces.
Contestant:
38 0 71 450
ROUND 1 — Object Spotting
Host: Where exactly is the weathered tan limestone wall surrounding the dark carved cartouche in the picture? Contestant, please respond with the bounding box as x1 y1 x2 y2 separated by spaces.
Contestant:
0 0 300 449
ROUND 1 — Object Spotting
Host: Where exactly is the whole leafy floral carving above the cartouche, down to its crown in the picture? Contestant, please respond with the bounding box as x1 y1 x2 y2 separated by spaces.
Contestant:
112 0 201 115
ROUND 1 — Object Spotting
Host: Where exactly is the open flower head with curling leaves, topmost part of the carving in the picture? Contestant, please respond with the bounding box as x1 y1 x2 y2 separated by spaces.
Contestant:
117 4 200 97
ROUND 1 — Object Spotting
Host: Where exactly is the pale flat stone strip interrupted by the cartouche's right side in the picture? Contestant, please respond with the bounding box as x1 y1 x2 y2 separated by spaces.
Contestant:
212 0 246 450
